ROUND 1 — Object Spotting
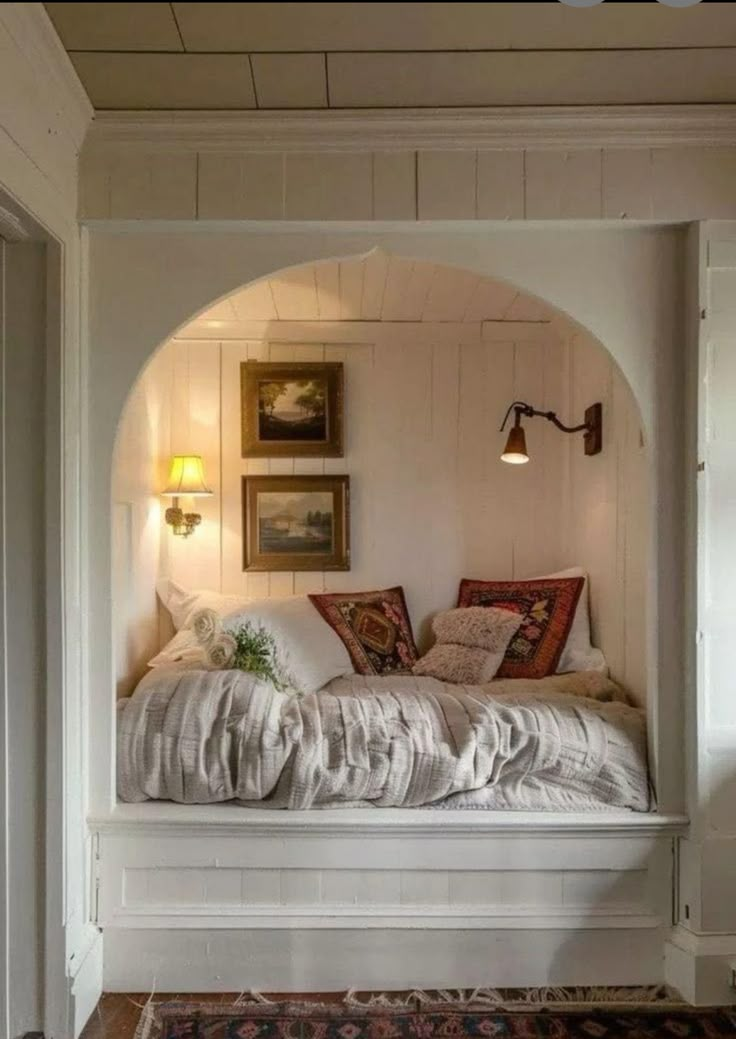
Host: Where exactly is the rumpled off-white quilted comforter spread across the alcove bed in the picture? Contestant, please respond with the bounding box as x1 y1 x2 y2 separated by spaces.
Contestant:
117 668 651 811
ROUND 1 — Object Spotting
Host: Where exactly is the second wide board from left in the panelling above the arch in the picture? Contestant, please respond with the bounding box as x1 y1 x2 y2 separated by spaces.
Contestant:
196 152 284 220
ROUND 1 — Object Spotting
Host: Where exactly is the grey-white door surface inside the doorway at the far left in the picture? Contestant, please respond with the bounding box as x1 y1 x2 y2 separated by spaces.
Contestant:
0 240 47 1036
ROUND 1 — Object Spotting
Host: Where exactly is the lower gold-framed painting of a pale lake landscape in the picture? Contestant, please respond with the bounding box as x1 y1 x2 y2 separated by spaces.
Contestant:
242 476 350 570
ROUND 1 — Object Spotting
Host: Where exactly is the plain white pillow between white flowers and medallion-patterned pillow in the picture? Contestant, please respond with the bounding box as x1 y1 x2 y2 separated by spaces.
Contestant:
222 595 354 694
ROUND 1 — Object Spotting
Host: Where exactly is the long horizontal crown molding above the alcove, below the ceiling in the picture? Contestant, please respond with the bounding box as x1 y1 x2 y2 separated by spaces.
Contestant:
85 105 736 153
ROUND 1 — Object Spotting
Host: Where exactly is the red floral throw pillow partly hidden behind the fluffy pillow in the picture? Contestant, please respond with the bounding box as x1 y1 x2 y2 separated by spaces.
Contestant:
457 578 583 678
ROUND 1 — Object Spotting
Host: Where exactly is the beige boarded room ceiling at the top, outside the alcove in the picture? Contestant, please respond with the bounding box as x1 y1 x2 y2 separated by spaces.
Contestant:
46 2 736 110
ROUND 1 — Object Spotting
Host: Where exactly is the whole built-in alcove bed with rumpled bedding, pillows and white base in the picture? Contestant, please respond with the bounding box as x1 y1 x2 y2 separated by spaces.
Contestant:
106 578 665 991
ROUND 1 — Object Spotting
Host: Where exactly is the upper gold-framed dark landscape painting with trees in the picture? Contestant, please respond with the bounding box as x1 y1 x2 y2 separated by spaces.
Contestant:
240 361 343 458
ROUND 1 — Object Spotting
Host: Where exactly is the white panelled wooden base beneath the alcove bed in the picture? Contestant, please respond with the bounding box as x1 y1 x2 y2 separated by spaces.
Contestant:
93 805 681 991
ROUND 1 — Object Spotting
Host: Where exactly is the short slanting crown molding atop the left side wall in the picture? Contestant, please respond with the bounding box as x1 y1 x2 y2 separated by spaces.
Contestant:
0 3 95 150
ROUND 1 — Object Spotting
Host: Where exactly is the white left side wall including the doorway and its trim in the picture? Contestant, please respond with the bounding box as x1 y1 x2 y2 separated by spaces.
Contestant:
0 3 96 1039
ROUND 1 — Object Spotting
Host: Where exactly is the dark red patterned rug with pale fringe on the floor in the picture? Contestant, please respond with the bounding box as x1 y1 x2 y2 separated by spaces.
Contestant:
145 998 736 1039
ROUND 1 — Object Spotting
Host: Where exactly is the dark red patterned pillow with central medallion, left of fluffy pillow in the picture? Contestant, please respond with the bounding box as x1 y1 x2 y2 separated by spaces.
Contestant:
310 587 417 674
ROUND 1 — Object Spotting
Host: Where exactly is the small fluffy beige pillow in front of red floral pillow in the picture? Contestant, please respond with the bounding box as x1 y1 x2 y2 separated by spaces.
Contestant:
413 606 524 686
